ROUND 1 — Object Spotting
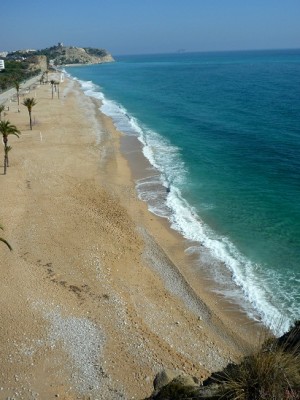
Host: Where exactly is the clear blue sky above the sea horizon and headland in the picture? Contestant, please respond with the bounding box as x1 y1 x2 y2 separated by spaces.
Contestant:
0 0 300 55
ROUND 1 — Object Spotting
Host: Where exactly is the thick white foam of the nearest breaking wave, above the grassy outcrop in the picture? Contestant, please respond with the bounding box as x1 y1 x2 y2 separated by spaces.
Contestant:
167 190 296 334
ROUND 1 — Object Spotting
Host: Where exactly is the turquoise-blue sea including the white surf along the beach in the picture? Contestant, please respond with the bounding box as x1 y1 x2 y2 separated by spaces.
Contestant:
65 49 300 334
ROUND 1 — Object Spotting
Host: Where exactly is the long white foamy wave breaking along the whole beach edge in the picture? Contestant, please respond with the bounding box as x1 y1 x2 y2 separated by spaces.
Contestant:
73 74 297 334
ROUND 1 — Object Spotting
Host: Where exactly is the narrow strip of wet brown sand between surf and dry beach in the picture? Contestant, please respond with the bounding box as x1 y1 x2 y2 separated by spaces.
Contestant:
77 76 270 358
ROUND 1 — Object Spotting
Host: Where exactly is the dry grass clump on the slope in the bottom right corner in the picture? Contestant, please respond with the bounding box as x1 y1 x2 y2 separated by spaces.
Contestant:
216 323 300 400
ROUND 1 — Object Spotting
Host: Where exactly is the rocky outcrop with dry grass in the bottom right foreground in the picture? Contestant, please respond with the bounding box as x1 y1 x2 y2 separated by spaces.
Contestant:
145 321 300 400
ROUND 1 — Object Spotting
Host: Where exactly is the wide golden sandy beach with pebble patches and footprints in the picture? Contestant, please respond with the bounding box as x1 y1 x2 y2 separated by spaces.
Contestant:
0 77 257 400
